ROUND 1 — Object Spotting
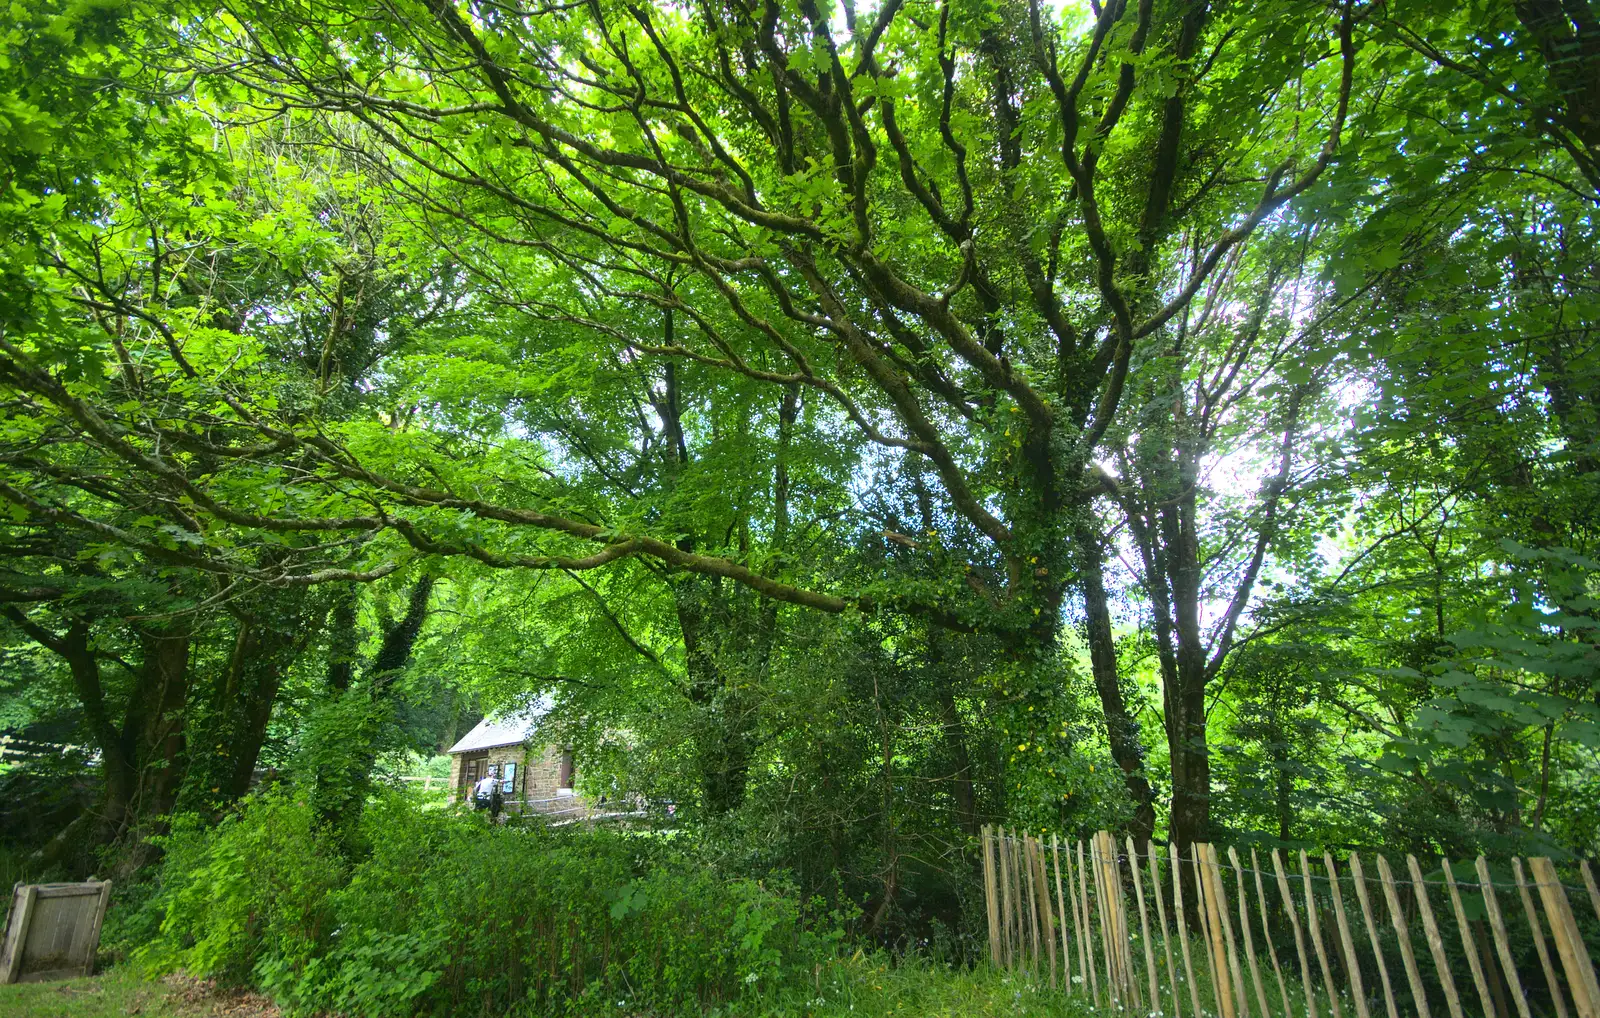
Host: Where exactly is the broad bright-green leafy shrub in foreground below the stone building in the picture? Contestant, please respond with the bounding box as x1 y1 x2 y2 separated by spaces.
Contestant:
152 792 832 1018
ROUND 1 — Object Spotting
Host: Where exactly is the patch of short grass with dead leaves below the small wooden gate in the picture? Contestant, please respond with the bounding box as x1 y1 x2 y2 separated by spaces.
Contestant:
0 968 278 1018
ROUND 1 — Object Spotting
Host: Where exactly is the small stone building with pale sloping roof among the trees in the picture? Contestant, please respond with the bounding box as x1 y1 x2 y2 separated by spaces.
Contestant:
446 698 589 815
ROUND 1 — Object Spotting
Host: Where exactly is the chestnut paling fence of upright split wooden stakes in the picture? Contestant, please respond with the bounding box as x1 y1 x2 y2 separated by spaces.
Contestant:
982 828 1600 1018
